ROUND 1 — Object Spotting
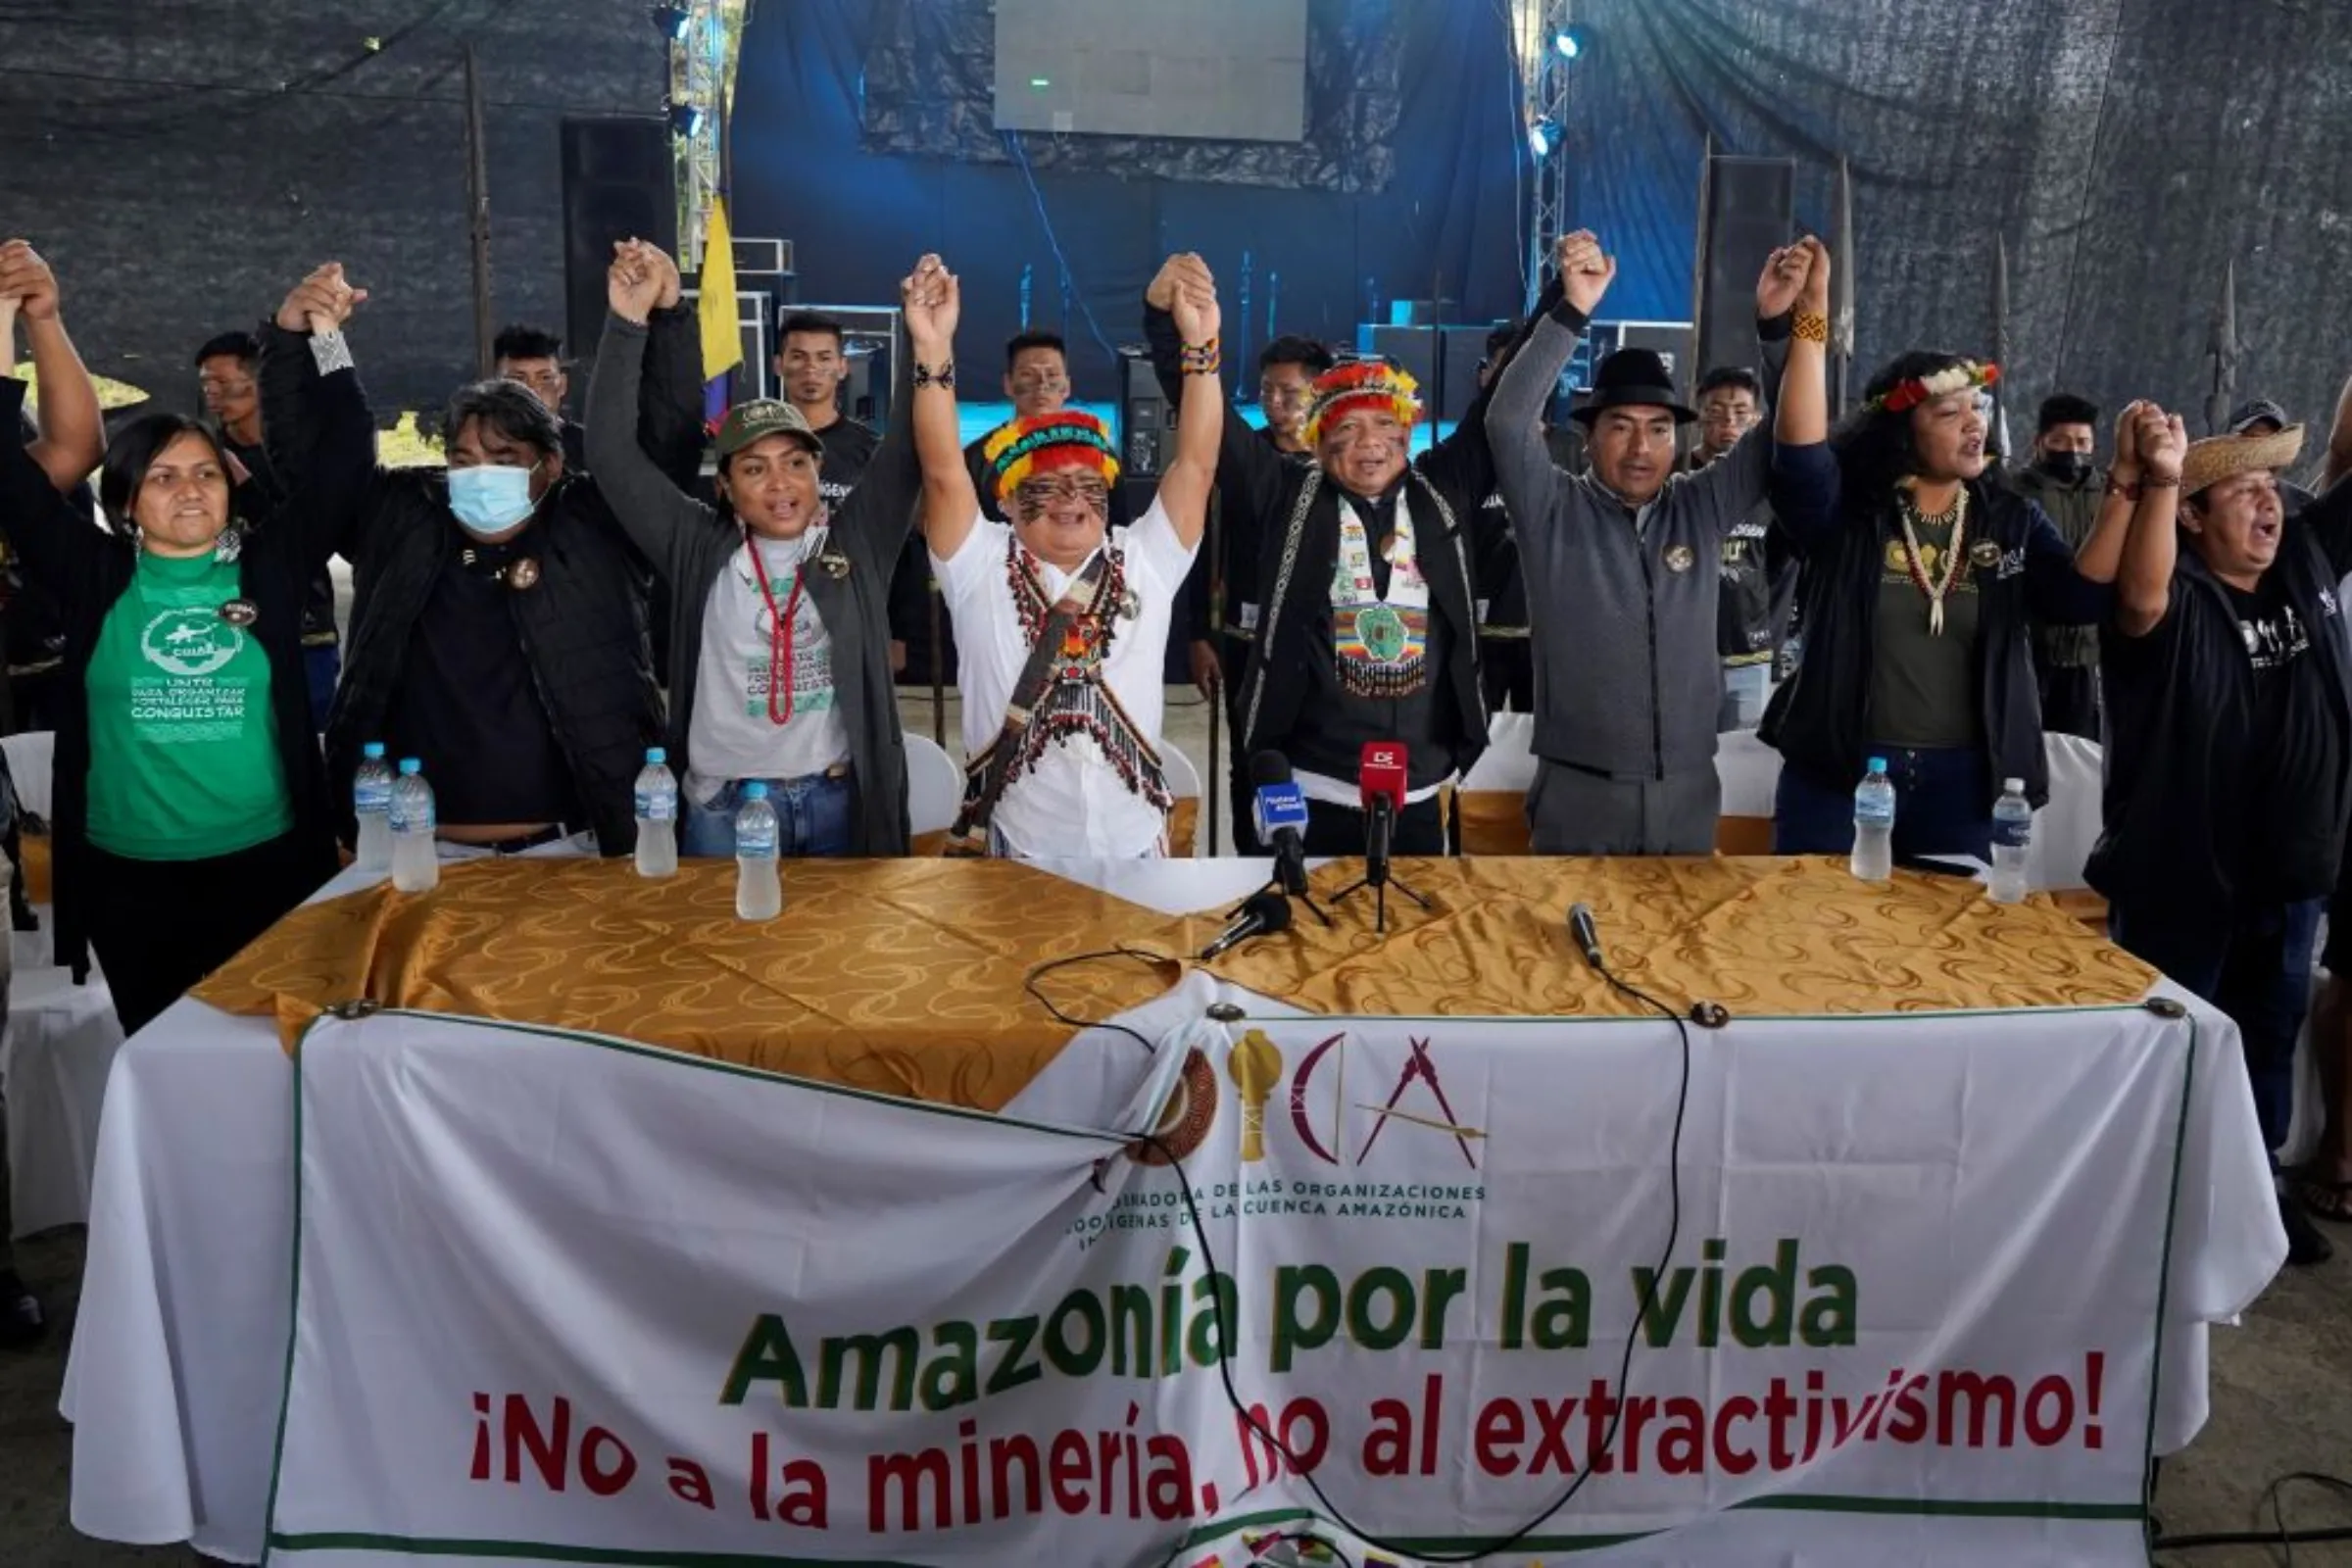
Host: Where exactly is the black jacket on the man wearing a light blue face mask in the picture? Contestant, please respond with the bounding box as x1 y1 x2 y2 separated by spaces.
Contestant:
261 311 701 856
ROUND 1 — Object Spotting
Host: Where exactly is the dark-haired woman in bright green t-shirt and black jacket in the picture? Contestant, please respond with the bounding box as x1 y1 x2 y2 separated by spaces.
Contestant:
0 248 334 1034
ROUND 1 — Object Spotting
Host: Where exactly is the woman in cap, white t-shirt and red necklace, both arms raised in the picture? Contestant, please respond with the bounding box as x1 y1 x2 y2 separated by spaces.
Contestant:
588 244 969 858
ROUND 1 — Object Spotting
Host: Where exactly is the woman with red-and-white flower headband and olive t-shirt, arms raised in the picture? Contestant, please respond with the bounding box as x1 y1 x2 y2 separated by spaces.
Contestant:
1762 252 2131 860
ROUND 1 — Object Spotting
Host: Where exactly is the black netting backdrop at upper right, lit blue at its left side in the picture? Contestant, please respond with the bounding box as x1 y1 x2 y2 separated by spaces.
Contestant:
1564 0 2352 440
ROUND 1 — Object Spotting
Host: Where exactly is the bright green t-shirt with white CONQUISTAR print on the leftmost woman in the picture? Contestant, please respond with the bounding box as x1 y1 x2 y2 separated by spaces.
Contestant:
84 553 294 860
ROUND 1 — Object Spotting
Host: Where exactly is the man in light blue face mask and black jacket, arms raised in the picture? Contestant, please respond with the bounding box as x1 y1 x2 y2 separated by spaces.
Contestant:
261 242 701 856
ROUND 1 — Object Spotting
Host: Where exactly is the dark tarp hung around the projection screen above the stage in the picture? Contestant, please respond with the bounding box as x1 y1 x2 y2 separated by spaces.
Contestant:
860 0 1392 193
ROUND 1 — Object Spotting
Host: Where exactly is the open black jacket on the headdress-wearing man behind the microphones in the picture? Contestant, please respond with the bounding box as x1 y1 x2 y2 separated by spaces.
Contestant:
1143 306 1505 773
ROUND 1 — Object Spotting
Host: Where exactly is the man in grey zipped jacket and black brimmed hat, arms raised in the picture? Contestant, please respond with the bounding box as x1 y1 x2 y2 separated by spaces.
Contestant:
1487 232 1821 856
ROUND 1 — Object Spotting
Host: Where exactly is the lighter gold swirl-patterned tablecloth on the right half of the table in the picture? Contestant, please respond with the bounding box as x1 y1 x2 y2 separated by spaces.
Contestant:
1190 856 2157 1018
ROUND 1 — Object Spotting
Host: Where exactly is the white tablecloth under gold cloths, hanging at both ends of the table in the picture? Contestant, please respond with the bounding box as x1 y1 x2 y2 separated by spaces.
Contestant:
61 860 2286 1563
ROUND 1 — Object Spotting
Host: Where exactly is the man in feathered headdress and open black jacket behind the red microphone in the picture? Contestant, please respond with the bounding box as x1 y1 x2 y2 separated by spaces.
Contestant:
1143 256 1503 856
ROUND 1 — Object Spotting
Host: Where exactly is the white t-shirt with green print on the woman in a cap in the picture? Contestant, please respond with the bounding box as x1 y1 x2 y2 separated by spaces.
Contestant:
677 526 849 802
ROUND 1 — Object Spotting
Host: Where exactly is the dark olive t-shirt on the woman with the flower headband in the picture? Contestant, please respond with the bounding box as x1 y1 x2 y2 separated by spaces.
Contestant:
1868 524 1985 750
